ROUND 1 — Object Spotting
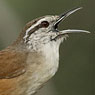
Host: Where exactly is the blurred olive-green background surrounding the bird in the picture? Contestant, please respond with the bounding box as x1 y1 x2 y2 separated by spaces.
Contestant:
0 0 95 95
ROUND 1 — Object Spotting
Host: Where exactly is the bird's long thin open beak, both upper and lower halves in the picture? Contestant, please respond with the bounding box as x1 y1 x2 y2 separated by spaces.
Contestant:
54 7 90 34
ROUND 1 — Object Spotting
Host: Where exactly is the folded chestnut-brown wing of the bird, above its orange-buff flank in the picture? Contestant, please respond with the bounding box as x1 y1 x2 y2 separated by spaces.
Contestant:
0 50 27 79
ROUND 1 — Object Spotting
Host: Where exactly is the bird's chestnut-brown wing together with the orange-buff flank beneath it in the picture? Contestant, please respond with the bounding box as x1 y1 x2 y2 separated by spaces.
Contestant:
0 48 27 95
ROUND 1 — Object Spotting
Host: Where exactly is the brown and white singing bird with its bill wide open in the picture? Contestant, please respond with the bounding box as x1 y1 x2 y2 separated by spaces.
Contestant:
0 7 90 95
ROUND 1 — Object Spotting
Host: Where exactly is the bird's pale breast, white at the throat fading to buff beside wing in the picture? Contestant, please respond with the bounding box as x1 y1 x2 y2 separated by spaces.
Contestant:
18 43 59 95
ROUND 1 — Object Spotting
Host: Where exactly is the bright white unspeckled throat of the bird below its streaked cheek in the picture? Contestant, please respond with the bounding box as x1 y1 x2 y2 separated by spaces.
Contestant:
42 41 60 77
